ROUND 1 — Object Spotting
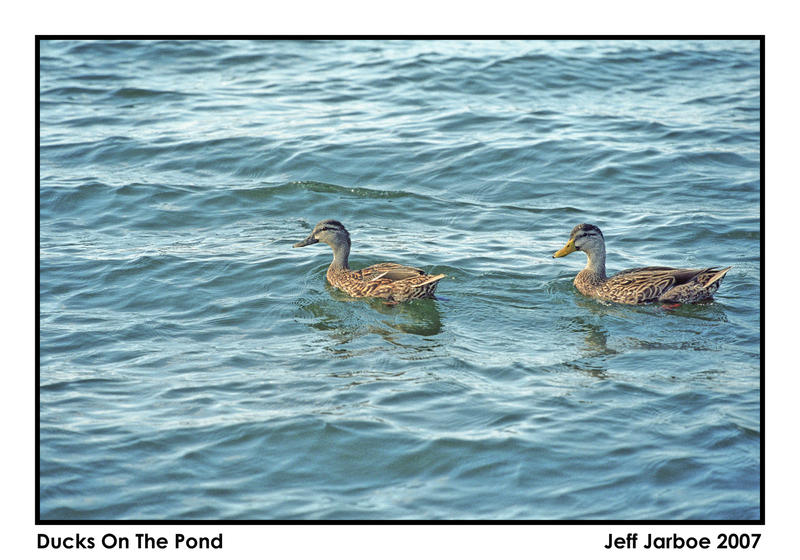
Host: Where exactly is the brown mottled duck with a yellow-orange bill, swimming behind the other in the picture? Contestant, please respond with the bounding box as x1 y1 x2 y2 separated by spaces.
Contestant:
553 224 733 307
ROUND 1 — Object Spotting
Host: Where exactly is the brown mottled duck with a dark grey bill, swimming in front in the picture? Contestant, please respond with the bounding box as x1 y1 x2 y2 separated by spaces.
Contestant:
293 219 446 304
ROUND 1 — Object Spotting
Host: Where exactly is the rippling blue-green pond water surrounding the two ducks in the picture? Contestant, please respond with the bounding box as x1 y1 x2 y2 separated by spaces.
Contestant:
39 41 761 519
